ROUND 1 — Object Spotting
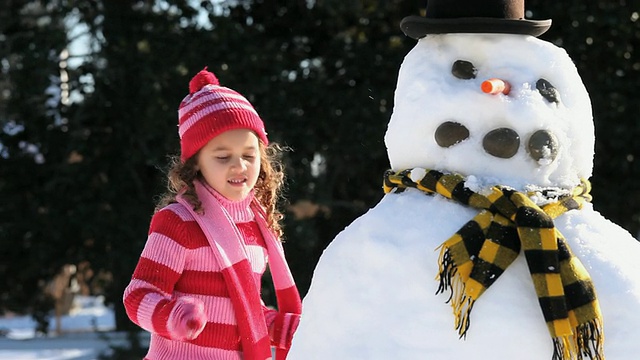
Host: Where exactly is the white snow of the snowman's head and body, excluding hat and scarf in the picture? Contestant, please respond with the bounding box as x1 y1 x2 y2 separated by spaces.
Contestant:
289 34 640 360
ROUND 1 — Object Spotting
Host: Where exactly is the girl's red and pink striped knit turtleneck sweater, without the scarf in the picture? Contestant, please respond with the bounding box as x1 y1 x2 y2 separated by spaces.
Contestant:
123 192 297 360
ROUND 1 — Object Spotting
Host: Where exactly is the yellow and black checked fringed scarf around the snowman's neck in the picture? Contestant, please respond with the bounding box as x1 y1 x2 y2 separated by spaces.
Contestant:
384 169 604 360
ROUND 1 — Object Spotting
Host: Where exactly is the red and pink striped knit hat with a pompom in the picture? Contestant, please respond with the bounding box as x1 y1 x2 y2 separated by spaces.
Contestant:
178 67 269 162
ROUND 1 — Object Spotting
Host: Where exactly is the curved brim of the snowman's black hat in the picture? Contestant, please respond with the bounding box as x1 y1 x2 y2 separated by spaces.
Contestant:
400 15 551 39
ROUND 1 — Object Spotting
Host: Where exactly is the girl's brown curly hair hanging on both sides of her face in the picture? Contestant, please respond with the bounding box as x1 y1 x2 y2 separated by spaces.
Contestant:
155 141 284 239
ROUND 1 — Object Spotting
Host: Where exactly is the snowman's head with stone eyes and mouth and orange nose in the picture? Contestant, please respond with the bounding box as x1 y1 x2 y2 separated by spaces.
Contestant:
385 34 594 189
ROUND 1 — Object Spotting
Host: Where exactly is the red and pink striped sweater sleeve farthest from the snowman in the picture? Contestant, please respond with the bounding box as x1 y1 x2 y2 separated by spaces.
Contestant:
123 206 198 339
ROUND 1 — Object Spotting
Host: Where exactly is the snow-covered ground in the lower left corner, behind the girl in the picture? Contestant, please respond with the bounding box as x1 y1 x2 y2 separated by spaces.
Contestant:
0 296 147 360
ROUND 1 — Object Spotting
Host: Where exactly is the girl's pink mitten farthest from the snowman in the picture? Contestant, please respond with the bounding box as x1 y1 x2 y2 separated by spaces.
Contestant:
167 297 207 340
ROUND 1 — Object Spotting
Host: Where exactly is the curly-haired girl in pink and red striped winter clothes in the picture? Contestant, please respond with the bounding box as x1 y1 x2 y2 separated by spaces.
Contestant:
123 68 301 360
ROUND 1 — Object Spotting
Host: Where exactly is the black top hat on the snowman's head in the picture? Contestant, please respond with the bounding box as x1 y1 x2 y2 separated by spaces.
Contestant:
400 0 551 39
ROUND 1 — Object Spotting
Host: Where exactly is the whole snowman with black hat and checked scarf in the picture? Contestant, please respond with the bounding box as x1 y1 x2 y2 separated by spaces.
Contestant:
289 0 640 360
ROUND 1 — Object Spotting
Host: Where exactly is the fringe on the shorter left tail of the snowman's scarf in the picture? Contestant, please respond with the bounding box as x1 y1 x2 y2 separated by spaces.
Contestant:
436 246 475 339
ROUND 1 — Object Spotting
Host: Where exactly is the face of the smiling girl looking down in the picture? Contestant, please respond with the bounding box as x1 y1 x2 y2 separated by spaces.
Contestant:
197 129 260 201
